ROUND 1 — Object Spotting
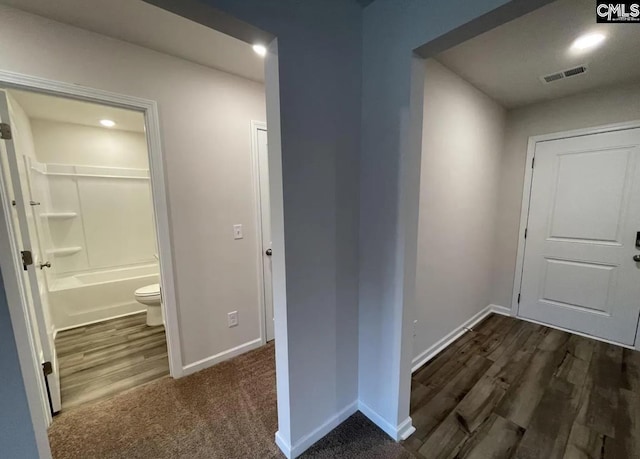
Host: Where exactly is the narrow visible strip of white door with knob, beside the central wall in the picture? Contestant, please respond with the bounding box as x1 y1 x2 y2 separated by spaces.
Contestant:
257 128 275 341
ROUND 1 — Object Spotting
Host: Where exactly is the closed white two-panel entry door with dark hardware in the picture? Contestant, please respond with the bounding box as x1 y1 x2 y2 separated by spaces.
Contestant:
518 129 640 345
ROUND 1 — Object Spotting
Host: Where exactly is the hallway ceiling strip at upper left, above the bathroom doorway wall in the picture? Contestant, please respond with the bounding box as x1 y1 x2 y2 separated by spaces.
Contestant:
0 0 264 81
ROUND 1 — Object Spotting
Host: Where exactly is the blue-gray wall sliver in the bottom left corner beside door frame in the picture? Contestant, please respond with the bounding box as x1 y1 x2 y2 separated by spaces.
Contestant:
0 270 38 459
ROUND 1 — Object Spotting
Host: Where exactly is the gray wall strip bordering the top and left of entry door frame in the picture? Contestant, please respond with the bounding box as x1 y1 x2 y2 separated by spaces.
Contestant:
491 84 640 307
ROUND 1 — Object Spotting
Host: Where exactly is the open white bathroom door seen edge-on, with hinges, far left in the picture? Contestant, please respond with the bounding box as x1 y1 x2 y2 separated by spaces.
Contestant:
0 91 61 413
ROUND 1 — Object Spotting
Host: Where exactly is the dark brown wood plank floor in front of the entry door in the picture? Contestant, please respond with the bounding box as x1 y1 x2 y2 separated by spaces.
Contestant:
404 315 640 459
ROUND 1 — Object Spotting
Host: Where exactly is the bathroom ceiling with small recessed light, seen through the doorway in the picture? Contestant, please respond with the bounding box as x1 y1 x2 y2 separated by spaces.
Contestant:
9 89 144 132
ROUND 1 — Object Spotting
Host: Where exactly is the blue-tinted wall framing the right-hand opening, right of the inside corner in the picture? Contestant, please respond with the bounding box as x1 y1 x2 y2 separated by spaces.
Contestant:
358 0 548 433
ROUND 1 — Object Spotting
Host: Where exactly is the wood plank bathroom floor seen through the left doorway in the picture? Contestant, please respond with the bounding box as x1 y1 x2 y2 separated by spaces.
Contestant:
55 313 169 411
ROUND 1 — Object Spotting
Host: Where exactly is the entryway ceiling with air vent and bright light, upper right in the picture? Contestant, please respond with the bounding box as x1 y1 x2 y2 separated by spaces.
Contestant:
436 0 640 108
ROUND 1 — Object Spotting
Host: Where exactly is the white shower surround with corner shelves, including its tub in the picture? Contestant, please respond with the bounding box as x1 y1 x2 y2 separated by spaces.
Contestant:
29 161 159 331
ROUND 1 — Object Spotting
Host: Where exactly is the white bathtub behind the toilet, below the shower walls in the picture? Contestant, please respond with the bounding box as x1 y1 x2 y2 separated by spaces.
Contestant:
48 263 160 331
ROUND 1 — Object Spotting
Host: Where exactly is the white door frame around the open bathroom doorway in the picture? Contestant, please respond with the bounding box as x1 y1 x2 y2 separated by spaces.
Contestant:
0 70 183 444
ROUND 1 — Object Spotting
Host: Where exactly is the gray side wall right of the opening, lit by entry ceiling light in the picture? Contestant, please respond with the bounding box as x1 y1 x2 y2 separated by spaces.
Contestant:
413 59 506 364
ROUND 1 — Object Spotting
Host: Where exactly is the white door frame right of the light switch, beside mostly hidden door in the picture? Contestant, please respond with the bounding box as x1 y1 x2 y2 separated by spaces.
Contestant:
251 120 268 345
